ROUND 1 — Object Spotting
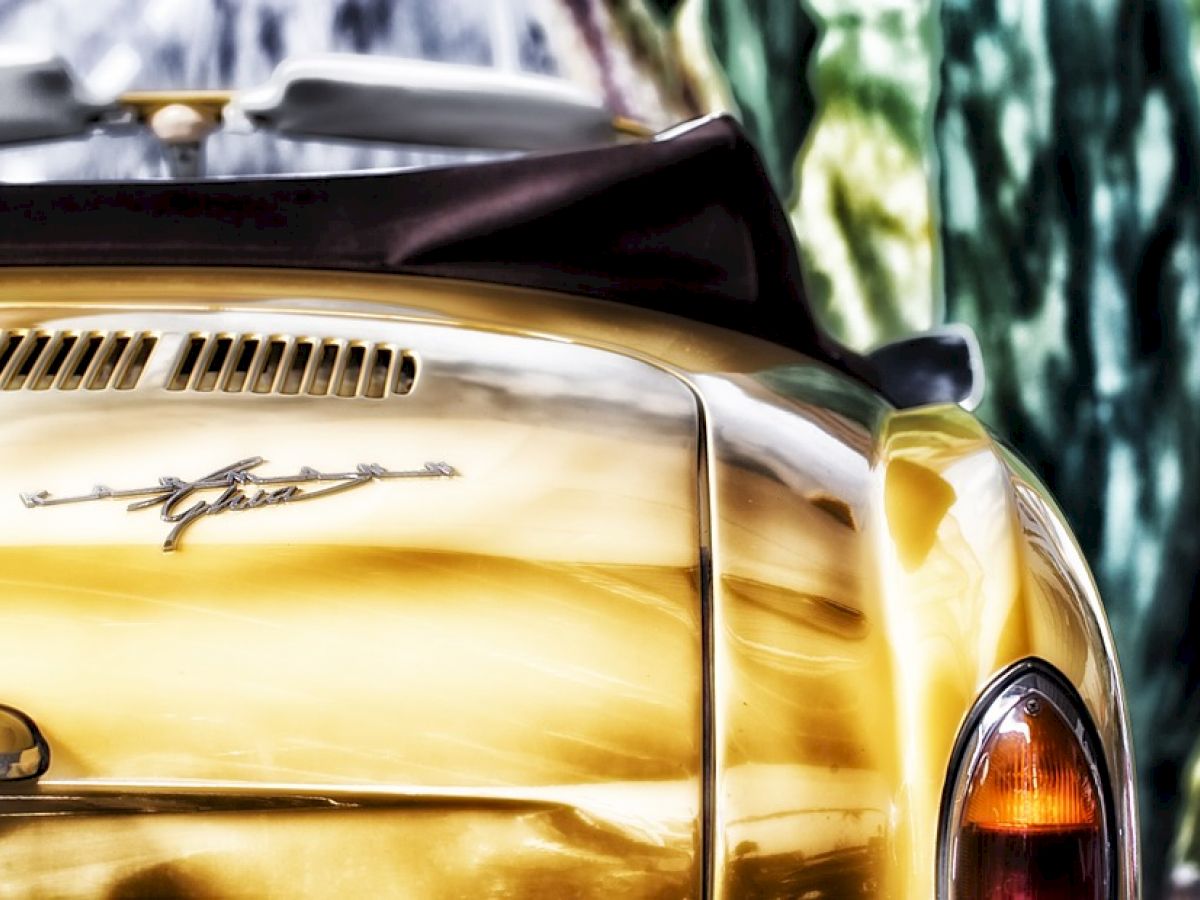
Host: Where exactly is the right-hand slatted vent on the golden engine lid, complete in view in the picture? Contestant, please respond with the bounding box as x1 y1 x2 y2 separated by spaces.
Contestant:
167 334 416 400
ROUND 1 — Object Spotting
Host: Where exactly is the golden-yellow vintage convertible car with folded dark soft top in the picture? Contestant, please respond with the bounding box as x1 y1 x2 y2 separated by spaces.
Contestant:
0 52 1138 900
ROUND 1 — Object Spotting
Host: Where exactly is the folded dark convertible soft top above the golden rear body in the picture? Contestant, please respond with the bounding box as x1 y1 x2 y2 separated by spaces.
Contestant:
0 116 874 380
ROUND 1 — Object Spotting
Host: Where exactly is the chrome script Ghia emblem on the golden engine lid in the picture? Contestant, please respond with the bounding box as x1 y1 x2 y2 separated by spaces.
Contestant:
20 456 458 552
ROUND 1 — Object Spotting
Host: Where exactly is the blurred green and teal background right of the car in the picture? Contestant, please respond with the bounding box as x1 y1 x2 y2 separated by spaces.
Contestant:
604 0 1200 899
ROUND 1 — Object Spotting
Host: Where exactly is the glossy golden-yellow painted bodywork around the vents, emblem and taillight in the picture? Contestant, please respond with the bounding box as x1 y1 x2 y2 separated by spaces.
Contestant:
0 270 1135 900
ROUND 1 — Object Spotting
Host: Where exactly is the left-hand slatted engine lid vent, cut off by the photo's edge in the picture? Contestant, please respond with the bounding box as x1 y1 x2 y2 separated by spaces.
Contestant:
0 329 158 391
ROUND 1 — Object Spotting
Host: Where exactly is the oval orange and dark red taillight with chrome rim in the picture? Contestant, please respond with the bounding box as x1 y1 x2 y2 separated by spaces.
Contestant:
938 660 1114 900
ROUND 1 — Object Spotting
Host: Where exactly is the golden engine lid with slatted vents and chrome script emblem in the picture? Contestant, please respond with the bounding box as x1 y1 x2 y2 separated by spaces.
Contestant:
0 310 702 894
